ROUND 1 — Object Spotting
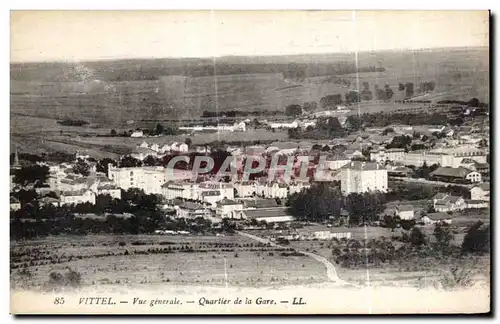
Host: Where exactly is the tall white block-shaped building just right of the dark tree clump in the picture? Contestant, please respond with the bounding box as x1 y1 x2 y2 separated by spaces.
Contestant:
340 161 387 195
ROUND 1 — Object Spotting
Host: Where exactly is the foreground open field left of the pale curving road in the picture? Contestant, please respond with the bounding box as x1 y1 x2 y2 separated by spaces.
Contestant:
11 235 328 289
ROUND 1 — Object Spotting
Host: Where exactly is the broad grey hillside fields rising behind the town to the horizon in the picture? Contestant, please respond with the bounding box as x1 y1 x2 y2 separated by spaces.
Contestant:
11 48 489 127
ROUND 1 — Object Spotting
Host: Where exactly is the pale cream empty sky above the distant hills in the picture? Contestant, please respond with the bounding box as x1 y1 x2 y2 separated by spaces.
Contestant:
10 11 489 62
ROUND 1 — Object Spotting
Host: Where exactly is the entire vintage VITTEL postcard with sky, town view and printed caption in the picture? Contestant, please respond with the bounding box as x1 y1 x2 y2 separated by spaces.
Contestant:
9 10 491 314
